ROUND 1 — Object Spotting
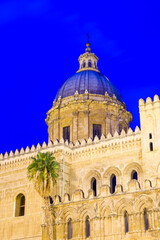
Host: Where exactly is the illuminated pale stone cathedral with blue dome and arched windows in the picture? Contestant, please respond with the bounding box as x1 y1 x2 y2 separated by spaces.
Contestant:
0 43 160 240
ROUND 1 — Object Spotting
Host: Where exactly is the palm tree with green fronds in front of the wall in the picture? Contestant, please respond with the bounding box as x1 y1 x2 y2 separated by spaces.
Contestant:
27 152 60 240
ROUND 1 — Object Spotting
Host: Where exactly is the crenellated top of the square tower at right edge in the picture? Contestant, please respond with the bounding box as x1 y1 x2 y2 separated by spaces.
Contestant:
139 95 160 110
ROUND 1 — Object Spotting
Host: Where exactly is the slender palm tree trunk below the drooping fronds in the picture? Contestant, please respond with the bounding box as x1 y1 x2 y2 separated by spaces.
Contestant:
44 197 53 240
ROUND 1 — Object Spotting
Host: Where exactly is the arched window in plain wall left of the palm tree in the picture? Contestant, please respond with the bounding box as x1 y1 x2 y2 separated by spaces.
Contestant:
15 193 25 217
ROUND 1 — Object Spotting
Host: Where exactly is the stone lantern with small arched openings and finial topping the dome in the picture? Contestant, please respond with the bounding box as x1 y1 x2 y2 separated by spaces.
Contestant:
77 40 99 72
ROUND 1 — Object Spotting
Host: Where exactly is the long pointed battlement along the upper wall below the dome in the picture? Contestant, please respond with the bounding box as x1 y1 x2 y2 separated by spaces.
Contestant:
0 126 141 166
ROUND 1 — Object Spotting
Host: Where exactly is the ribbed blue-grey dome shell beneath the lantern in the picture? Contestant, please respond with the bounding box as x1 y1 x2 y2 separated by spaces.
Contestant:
56 70 123 103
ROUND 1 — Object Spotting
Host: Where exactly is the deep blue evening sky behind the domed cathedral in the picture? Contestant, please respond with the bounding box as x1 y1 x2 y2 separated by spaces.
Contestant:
0 0 160 153
